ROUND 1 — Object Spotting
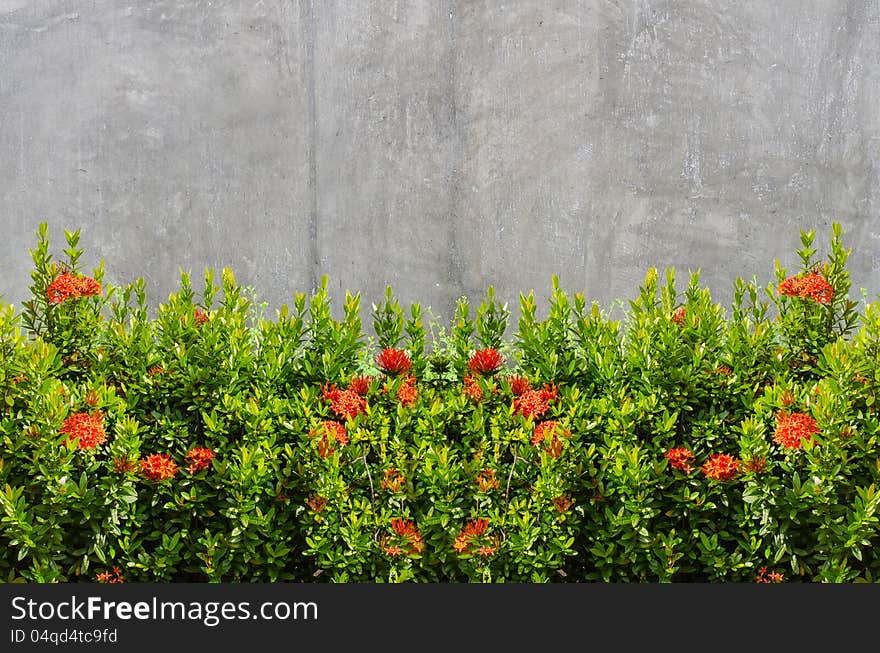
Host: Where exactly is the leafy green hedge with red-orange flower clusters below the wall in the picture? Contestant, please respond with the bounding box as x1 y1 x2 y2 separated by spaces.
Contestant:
0 225 880 583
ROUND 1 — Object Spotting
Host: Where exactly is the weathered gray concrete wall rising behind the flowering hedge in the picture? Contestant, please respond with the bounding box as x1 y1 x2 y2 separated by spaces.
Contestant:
0 0 880 326
